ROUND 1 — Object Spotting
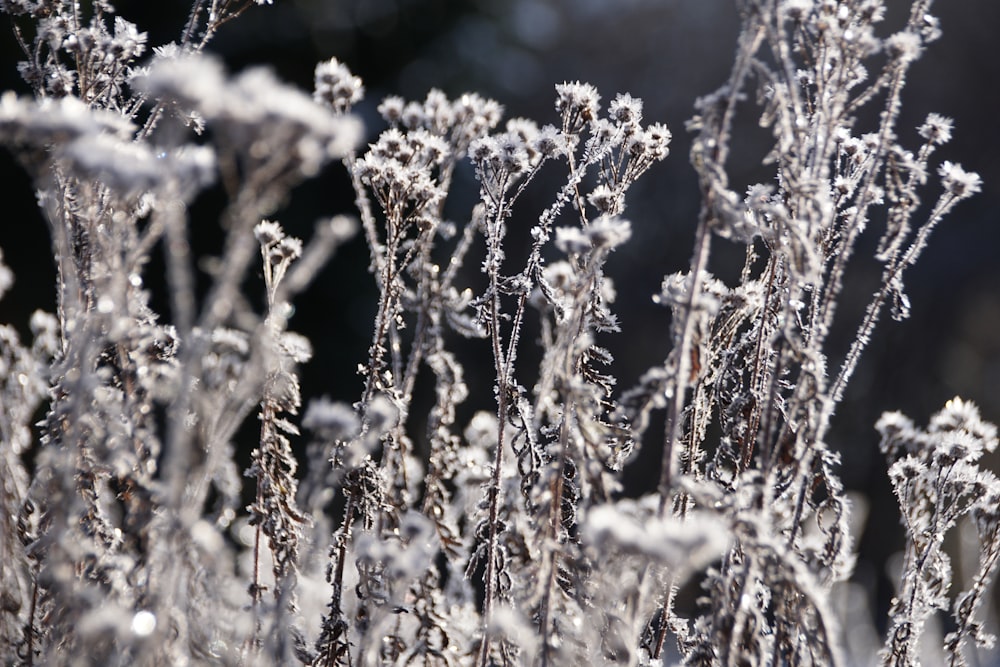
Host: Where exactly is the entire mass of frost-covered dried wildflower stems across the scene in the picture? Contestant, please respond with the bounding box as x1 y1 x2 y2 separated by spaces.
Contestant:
0 0 988 667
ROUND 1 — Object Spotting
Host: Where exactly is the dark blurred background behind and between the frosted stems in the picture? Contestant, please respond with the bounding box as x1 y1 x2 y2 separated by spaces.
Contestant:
0 0 1000 636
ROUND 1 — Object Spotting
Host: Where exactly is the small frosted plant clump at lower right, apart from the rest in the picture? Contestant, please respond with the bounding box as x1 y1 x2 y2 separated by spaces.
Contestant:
876 398 1000 666
